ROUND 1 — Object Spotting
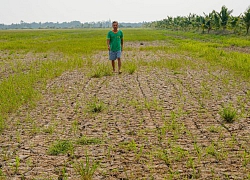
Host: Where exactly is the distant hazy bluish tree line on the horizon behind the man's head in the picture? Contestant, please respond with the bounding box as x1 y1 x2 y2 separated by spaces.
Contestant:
0 20 144 29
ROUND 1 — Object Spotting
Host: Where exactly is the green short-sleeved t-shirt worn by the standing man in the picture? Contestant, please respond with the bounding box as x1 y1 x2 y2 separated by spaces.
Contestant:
107 30 123 51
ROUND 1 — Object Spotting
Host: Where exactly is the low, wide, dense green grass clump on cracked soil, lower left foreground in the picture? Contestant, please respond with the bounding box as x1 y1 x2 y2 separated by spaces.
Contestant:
48 140 74 155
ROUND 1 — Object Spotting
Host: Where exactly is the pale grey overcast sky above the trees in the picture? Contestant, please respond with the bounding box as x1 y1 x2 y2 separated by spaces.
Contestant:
0 0 250 24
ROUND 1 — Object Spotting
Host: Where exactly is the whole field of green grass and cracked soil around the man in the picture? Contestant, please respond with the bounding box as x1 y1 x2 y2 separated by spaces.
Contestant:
0 29 250 180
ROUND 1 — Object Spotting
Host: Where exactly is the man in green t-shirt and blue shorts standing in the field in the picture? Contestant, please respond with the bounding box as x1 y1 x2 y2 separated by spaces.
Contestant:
107 21 123 74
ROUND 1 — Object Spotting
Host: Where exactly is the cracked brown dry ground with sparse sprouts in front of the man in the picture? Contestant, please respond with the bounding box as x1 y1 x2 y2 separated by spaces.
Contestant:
0 42 250 180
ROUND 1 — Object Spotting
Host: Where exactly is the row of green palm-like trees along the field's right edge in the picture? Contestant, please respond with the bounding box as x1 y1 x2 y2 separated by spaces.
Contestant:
144 6 250 34
